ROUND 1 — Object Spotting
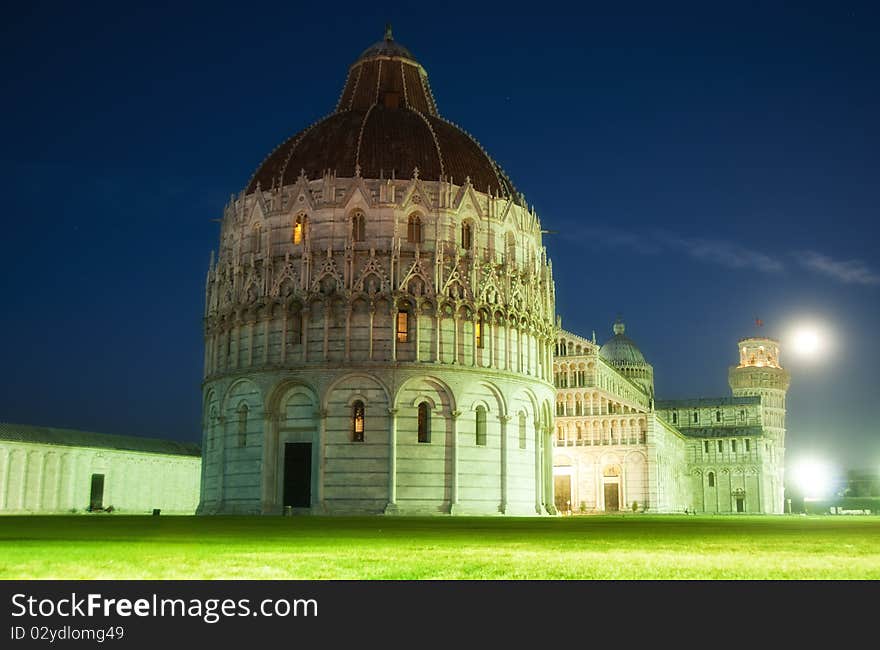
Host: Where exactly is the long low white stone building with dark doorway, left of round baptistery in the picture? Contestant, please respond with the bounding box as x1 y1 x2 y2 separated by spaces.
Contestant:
0 424 201 514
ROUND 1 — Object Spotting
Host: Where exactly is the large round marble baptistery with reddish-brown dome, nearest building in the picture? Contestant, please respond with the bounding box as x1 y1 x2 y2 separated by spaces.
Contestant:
199 31 556 515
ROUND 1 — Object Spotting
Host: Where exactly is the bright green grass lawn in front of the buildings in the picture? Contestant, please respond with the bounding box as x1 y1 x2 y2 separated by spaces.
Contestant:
0 515 880 579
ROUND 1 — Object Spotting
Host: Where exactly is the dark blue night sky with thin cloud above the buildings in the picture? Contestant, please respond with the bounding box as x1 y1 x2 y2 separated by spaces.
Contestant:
0 1 880 467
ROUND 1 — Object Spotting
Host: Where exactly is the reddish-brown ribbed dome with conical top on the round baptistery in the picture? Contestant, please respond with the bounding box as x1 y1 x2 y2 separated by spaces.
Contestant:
247 27 519 202
